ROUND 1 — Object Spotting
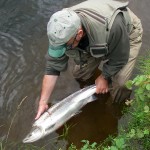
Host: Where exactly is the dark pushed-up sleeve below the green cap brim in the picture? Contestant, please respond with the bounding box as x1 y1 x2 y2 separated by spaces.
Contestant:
45 53 68 75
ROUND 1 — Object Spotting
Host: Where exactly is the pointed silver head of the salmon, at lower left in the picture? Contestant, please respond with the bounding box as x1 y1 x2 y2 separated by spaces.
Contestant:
23 126 43 143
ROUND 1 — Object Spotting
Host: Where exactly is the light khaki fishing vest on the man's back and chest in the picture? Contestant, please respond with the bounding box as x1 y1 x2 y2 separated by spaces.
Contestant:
69 0 131 57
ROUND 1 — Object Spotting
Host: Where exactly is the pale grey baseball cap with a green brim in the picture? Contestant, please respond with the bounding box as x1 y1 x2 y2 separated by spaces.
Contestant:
47 9 81 57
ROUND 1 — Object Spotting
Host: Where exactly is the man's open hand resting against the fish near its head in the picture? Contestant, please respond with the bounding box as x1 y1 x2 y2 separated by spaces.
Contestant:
35 101 48 120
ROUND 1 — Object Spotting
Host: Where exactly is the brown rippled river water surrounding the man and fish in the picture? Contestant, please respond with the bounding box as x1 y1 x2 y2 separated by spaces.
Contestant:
0 0 150 150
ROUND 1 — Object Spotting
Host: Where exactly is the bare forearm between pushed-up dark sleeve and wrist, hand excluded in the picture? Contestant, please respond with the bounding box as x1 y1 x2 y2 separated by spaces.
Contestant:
40 75 58 103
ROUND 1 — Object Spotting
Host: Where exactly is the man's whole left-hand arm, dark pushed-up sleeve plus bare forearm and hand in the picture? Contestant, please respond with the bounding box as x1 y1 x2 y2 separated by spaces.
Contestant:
35 52 68 119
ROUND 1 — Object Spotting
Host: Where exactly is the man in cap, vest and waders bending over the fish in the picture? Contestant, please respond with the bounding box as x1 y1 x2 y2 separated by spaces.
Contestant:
35 0 143 119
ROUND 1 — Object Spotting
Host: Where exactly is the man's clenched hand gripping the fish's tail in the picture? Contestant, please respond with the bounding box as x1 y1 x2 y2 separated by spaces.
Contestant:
95 75 108 94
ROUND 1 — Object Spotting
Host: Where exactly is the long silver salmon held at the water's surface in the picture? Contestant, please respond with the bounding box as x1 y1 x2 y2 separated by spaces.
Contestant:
23 85 96 143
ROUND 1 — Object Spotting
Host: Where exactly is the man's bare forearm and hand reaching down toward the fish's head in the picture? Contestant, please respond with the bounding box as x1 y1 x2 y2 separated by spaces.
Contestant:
35 75 58 119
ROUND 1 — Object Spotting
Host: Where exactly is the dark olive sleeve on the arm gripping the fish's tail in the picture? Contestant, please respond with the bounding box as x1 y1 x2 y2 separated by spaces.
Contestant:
102 14 130 79
